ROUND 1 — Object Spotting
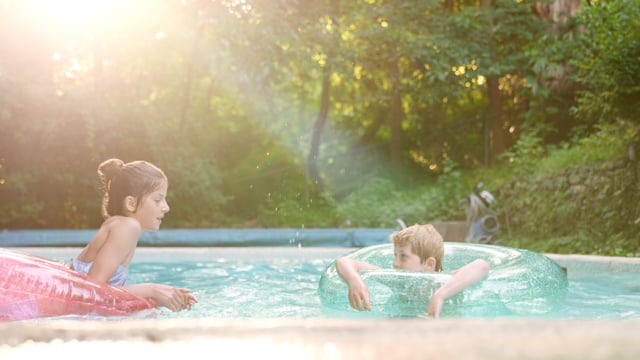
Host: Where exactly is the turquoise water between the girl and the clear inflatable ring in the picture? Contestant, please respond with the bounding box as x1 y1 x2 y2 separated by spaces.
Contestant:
128 253 333 318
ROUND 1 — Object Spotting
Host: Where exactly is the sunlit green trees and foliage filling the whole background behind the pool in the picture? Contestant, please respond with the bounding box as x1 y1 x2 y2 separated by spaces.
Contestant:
0 0 640 262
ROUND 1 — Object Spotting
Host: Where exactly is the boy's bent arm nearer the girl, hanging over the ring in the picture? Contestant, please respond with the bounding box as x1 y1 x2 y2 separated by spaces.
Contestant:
336 257 378 310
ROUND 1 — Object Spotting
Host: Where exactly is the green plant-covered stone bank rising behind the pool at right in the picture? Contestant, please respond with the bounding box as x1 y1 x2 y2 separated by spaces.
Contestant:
500 122 640 256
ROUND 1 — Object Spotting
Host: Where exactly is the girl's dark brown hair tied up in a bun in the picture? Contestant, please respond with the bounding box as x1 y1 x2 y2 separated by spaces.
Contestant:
98 159 167 219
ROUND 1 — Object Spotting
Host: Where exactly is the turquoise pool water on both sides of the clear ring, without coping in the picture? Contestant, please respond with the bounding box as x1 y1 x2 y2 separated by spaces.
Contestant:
129 255 640 319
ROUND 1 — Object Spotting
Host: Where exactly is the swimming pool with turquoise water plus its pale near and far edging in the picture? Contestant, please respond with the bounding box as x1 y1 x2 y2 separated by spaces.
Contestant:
0 240 640 360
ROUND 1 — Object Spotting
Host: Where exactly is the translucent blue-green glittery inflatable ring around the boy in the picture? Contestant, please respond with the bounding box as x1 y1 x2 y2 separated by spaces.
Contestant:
318 243 567 317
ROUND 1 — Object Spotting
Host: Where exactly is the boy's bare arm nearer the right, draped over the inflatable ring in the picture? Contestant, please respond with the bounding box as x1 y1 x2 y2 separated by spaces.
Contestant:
427 259 490 318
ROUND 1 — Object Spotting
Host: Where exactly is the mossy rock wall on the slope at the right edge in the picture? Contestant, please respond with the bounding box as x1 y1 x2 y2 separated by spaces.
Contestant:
498 158 640 241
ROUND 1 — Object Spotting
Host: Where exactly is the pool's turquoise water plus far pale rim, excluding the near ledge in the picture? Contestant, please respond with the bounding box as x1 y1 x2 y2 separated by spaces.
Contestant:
8 246 640 319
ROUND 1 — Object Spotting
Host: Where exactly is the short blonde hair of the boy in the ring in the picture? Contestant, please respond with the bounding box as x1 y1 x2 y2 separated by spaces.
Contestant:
389 224 444 271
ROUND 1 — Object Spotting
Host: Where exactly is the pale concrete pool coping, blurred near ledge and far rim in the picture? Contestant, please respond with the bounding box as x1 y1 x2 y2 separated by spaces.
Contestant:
0 247 640 360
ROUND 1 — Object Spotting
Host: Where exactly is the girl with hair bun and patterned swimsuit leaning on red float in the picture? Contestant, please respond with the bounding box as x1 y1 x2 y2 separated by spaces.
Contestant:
71 159 198 311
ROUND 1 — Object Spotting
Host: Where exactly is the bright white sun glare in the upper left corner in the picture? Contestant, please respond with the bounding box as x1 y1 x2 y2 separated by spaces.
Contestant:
0 0 162 88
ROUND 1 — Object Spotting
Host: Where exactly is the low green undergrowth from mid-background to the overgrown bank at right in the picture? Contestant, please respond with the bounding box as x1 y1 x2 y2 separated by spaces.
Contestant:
337 122 640 256
